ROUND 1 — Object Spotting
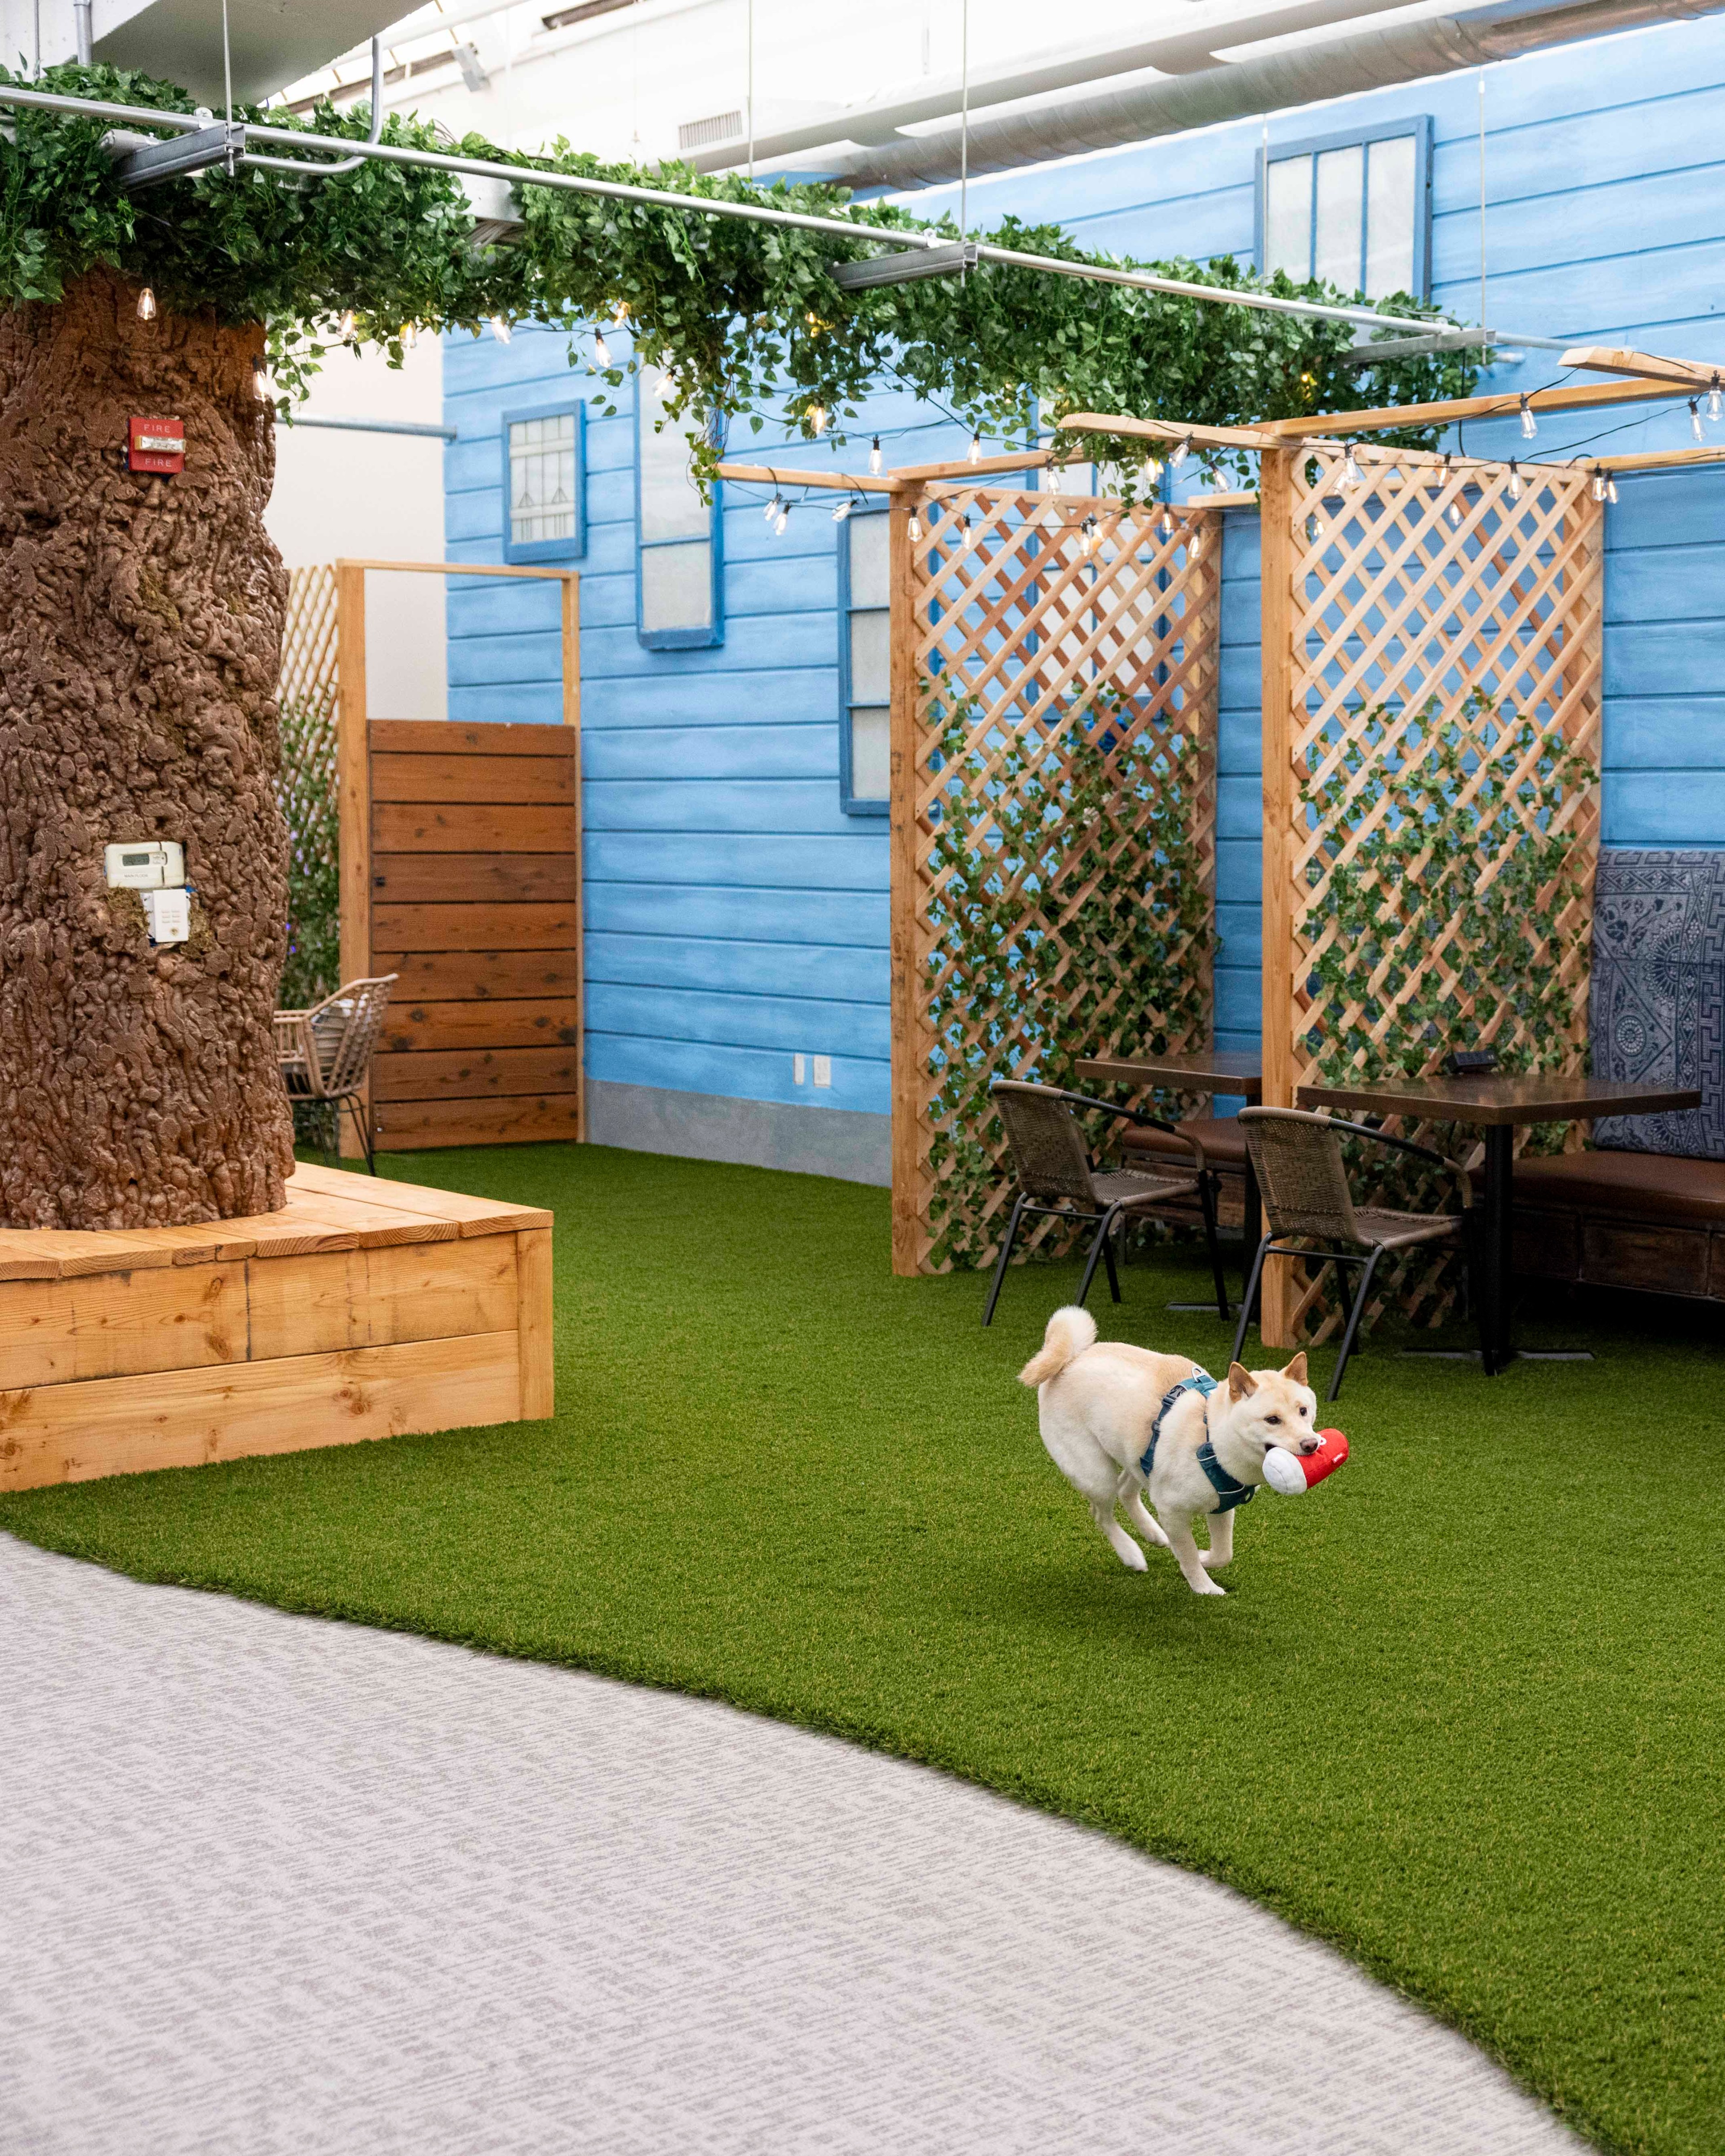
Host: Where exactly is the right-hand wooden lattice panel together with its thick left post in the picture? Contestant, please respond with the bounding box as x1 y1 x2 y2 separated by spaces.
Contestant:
1259 451 1604 1343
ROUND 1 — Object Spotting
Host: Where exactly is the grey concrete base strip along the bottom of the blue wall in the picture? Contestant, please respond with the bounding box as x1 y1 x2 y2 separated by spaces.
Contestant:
586 1078 893 1190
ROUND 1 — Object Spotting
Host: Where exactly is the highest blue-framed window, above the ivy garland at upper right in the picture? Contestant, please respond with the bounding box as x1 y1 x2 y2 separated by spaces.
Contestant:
1257 119 1432 300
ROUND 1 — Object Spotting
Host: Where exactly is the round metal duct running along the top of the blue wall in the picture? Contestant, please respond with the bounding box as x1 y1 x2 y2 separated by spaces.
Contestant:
785 0 1725 188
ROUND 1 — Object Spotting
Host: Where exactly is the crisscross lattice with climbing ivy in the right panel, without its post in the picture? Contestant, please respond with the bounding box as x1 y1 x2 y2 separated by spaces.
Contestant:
1287 453 1600 1337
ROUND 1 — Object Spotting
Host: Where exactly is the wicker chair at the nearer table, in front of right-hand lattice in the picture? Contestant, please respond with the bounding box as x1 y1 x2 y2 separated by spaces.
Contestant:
1233 1108 1473 1399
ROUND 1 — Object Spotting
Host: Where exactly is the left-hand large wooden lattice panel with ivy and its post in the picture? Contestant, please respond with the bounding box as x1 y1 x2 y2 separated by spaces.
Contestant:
893 489 1220 1272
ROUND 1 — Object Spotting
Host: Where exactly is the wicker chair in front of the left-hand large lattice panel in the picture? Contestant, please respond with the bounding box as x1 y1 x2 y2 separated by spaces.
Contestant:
983 1078 1229 1324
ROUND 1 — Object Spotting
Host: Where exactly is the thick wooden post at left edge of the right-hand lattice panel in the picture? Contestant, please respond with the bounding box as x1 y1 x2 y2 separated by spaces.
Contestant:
1257 448 1302 1347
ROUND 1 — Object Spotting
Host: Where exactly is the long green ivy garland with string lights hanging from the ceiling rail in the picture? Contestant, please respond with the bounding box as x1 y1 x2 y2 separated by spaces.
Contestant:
0 65 1475 466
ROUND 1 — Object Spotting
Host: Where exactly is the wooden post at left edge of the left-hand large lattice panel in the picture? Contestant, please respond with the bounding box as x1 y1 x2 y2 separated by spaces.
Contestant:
888 502 927 1274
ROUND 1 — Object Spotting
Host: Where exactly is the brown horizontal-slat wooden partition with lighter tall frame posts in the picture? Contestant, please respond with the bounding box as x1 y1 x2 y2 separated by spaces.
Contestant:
341 563 586 1151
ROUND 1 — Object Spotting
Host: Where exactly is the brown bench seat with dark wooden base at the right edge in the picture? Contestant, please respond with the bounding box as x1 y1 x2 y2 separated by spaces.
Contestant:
1516 1151 1725 1300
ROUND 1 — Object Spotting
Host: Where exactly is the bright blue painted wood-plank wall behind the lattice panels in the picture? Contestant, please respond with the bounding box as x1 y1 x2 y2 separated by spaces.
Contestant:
446 19 1725 1112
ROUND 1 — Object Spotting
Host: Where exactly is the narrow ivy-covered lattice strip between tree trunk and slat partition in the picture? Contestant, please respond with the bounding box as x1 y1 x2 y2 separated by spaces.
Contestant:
276 567 341 1009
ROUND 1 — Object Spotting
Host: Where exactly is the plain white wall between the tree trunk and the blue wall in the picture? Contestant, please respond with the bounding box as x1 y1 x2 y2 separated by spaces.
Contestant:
263 336 448 718
